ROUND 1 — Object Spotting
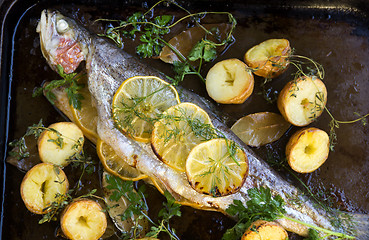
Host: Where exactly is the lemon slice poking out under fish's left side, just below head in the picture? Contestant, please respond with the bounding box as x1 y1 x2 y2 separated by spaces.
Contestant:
70 74 99 144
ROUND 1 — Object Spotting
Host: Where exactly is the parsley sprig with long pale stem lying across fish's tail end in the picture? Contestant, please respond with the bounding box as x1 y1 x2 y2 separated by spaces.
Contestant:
222 187 355 240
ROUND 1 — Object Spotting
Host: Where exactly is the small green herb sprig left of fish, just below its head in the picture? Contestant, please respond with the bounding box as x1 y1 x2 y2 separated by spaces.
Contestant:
32 65 85 110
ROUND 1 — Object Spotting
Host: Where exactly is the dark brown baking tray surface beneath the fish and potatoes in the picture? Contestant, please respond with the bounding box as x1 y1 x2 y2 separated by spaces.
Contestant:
0 0 369 239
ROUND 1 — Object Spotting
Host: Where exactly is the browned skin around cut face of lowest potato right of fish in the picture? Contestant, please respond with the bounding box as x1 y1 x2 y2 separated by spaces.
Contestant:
286 127 329 173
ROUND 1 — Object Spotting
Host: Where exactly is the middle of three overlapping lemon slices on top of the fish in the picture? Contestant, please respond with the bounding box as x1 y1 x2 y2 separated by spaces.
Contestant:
151 102 215 172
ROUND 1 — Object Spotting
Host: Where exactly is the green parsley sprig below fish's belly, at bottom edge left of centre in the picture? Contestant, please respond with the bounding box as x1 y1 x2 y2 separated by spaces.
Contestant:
106 174 181 240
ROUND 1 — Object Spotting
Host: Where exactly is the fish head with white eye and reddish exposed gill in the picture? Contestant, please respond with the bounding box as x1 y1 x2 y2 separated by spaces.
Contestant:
36 10 89 73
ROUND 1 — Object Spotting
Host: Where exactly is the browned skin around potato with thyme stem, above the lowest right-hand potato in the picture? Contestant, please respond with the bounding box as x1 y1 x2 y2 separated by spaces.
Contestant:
277 76 327 127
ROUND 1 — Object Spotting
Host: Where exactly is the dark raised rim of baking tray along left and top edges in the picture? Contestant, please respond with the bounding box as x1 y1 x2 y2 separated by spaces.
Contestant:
0 0 369 239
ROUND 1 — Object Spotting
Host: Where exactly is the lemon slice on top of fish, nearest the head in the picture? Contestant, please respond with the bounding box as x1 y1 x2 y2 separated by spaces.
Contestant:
112 76 180 142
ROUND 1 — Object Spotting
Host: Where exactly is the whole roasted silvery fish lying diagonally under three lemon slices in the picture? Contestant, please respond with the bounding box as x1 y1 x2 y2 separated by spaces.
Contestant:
37 10 369 240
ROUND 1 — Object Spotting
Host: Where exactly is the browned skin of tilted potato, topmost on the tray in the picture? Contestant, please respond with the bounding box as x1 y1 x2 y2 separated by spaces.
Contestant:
244 39 291 78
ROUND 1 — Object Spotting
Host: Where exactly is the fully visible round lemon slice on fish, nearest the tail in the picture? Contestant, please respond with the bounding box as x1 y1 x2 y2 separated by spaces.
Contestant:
186 138 248 197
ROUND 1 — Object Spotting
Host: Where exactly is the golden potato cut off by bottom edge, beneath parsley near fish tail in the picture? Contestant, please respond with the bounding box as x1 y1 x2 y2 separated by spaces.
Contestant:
241 220 288 240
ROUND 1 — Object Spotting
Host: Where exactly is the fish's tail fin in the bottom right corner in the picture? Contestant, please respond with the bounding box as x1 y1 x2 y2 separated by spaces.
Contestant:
340 212 369 240
